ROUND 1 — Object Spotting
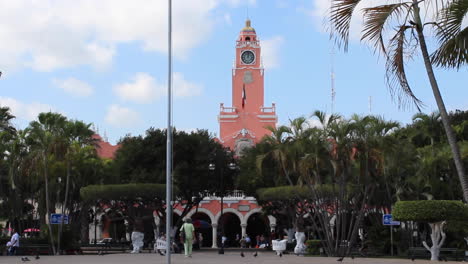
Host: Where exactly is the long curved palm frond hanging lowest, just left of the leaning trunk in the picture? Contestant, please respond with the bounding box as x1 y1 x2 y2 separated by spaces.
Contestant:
385 25 423 111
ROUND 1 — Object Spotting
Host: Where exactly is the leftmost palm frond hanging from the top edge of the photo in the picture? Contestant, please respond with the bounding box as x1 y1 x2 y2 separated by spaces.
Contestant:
330 0 361 51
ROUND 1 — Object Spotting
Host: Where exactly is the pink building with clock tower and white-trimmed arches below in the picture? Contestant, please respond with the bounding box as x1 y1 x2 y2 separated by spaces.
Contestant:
175 20 278 248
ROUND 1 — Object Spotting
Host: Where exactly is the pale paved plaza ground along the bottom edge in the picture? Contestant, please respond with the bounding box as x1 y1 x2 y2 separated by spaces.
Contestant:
0 251 460 264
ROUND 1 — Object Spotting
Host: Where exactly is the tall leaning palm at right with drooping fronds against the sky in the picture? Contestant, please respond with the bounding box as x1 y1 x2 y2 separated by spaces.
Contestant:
330 0 468 202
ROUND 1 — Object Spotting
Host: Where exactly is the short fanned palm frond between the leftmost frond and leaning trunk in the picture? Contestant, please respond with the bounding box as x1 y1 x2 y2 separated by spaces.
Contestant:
361 3 411 54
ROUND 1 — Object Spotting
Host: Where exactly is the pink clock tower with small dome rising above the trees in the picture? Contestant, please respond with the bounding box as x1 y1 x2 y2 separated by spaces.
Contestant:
218 20 278 156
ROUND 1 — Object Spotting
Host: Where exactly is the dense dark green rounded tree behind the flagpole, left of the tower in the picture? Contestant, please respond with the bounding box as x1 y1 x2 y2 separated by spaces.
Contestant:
113 129 234 229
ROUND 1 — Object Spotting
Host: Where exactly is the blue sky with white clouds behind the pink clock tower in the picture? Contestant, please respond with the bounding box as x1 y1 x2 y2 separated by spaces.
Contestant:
0 0 468 143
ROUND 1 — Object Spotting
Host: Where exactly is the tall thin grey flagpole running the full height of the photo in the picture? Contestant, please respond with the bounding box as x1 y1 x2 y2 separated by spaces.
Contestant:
166 0 172 264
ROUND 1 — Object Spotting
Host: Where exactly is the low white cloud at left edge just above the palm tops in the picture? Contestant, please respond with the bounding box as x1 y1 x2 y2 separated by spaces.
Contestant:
0 97 57 122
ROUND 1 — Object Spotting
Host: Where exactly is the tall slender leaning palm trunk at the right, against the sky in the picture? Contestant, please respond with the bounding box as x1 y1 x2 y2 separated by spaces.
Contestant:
413 0 468 203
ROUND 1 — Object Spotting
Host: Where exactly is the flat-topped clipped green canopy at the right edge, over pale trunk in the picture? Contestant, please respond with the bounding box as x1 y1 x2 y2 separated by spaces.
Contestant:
392 200 468 223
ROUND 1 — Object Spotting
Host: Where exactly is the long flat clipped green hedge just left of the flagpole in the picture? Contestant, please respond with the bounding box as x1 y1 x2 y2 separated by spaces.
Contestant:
80 183 166 202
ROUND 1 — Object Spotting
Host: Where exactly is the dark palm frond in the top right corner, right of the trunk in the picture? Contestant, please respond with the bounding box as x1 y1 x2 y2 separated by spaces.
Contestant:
431 0 468 69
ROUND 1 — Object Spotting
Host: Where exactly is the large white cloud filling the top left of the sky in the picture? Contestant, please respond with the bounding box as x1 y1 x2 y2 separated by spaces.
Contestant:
0 0 222 71
